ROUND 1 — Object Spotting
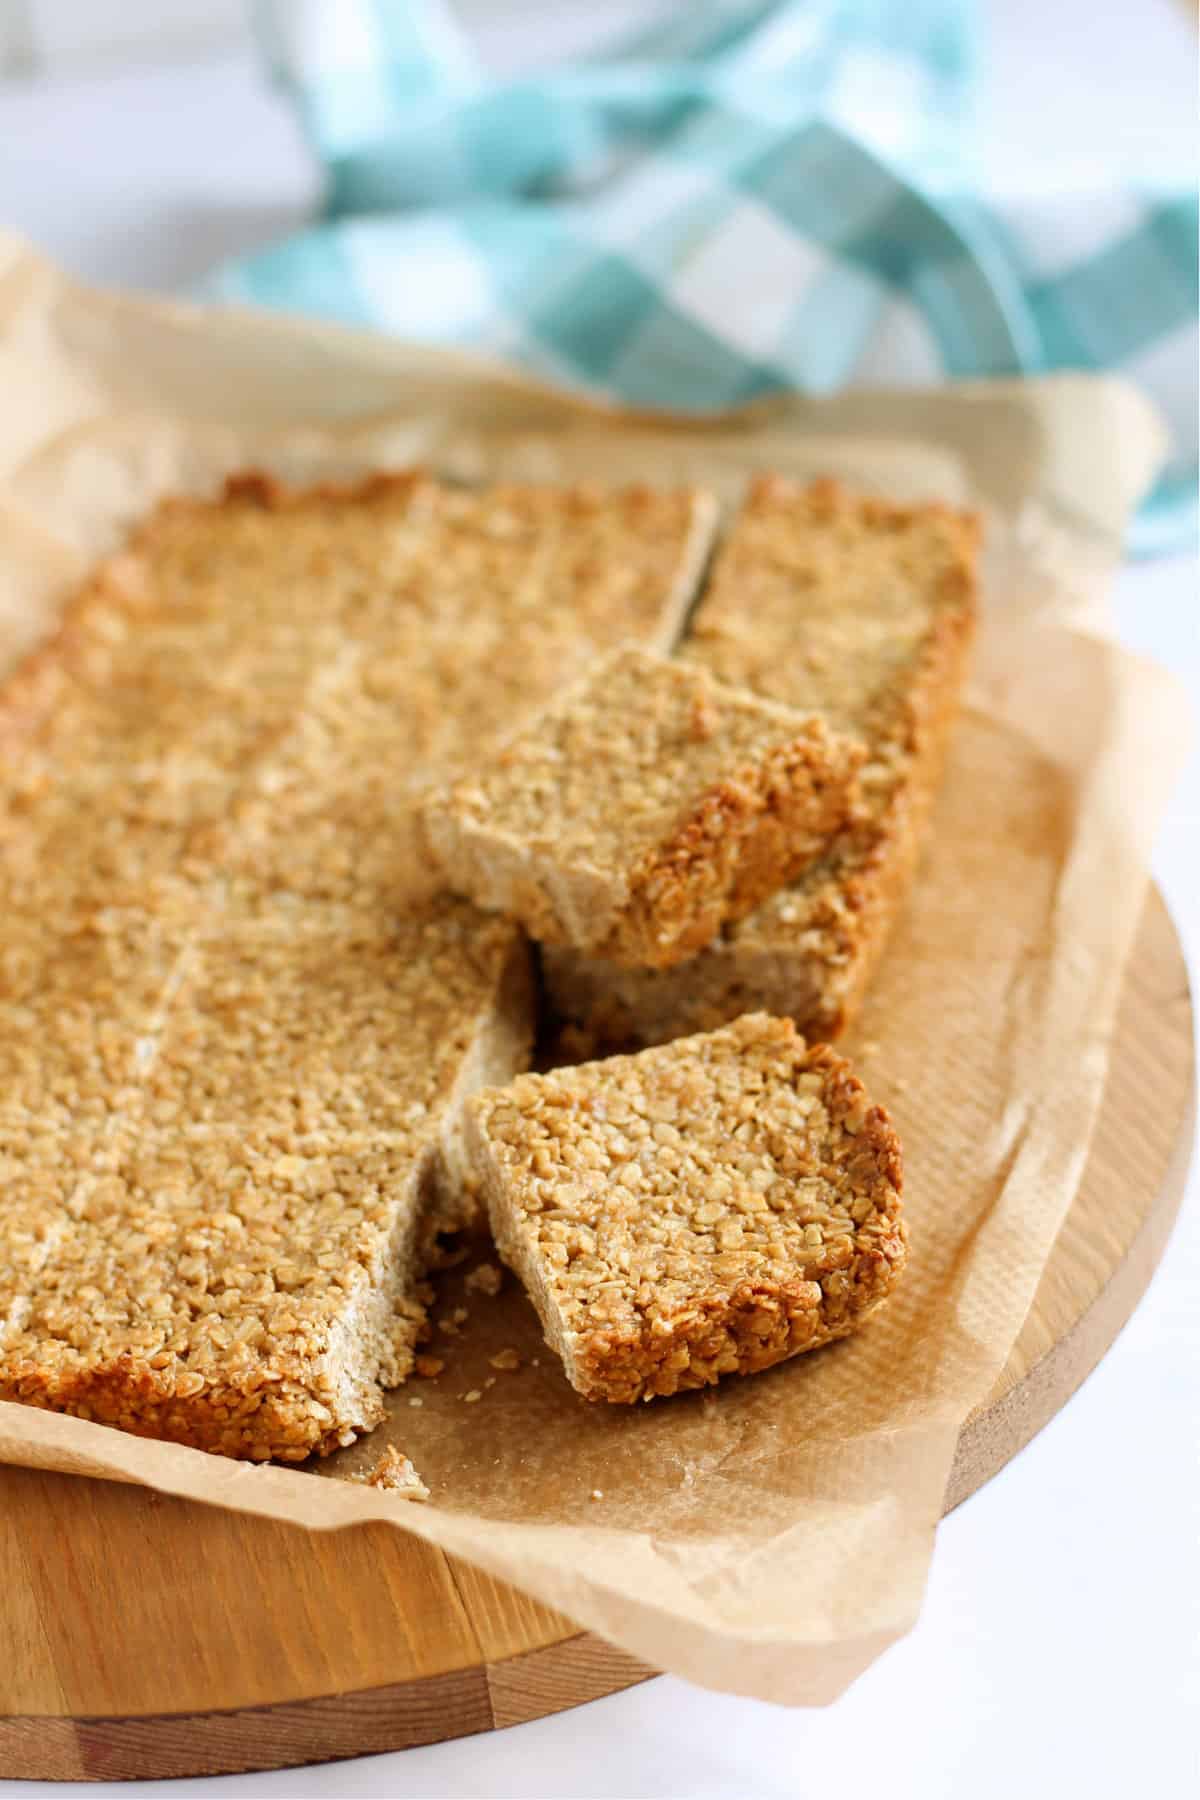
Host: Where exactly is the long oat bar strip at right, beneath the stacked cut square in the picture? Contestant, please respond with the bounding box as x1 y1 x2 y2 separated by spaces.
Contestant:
543 479 979 1046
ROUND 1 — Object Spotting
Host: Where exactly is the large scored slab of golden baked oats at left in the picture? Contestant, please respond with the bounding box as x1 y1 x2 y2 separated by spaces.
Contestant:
0 475 709 1460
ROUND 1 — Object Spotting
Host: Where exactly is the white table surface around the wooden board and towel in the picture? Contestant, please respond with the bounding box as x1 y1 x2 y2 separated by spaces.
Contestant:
0 0 1200 1800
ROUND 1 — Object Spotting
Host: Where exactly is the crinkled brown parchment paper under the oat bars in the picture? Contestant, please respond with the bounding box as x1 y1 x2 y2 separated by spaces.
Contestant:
0 239 1186 1703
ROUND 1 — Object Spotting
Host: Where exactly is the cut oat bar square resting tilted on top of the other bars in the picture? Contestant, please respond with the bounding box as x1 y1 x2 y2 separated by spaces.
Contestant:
425 646 862 968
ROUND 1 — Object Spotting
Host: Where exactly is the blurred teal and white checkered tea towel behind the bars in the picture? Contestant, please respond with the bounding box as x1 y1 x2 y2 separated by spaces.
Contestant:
205 0 1198 551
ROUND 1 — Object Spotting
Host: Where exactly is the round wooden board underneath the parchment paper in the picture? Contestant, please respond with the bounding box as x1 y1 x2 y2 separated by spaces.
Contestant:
0 895 1195 1780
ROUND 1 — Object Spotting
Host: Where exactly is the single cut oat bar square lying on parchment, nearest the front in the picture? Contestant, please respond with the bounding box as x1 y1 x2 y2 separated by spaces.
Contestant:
468 1013 905 1400
